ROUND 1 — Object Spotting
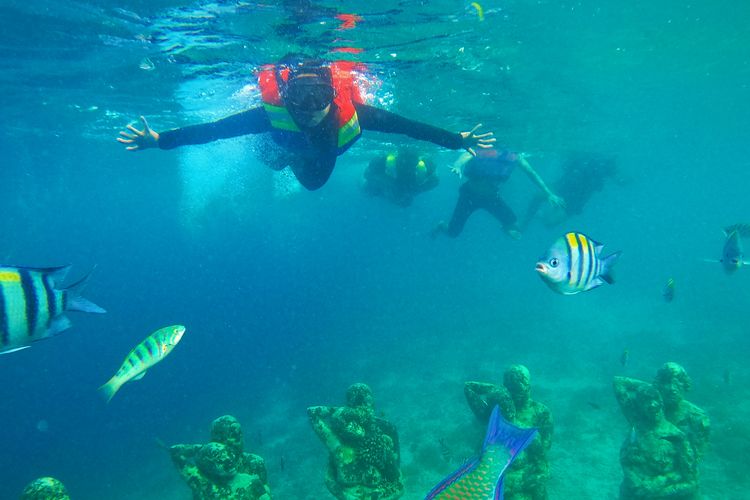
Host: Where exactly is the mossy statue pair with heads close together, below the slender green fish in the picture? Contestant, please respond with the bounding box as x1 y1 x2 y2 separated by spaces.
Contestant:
169 415 271 500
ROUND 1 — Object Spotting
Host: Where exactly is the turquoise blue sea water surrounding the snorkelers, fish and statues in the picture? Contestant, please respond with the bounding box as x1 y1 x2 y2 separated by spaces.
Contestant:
0 0 750 499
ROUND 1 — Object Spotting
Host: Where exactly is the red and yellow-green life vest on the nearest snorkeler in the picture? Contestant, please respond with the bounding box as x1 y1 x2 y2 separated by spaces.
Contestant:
258 61 364 155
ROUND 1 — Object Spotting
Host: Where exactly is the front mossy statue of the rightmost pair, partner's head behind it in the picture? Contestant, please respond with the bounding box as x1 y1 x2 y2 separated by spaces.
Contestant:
614 377 699 500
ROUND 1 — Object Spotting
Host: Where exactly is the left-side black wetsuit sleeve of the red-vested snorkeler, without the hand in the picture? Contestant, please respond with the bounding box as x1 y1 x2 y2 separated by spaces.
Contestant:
159 106 271 149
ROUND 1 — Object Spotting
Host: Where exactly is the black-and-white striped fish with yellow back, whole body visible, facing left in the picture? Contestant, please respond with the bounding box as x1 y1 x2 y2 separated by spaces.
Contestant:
536 233 622 295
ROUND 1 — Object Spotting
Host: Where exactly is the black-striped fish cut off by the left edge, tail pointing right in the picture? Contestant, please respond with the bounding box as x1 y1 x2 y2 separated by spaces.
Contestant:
0 266 105 354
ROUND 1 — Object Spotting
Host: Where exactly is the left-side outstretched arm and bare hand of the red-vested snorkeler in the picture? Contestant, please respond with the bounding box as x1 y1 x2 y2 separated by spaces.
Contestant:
117 106 271 151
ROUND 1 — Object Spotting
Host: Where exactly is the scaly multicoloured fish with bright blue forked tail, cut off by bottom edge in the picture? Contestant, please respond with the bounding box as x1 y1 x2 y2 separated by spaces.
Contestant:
425 406 536 500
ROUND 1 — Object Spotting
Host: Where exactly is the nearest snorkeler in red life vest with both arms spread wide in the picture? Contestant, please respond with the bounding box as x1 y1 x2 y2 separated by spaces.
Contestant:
117 61 495 190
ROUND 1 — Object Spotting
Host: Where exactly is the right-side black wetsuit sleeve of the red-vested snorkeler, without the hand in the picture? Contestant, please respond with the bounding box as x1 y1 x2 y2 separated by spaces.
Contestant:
355 104 463 149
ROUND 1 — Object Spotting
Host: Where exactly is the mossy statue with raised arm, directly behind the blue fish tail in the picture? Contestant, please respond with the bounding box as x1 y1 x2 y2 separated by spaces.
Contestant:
464 365 554 500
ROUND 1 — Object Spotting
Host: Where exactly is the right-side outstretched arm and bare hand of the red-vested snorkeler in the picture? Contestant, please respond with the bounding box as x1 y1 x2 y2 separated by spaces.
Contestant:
355 104 496 154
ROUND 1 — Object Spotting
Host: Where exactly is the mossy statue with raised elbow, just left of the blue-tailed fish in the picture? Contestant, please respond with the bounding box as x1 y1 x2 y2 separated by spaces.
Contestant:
307 384 404 500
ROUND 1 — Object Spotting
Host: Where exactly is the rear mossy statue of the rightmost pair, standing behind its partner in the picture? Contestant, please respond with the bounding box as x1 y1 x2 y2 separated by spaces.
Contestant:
653 363 711 460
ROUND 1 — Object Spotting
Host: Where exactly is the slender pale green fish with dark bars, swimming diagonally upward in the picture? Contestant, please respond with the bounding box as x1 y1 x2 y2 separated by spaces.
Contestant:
99 325 185 402
